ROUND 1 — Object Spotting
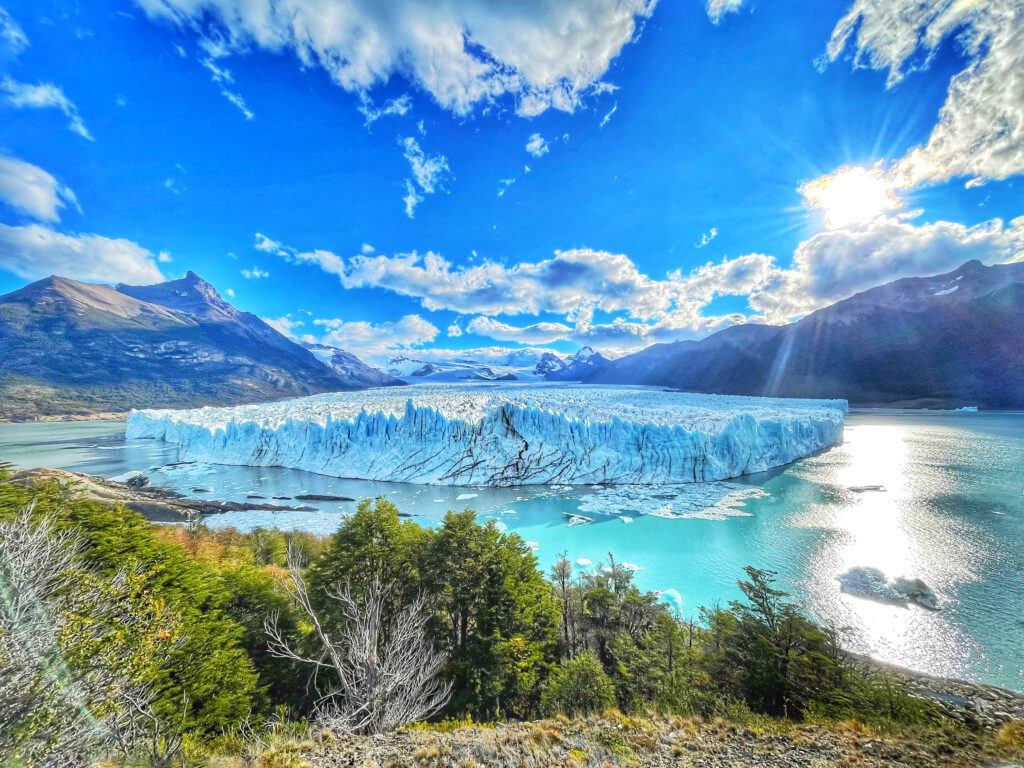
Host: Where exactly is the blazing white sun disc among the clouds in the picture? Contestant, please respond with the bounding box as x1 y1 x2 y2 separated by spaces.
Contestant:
799 166 901 229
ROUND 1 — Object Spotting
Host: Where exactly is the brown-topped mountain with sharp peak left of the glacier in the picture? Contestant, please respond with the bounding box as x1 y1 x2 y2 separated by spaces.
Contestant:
0 272 354 418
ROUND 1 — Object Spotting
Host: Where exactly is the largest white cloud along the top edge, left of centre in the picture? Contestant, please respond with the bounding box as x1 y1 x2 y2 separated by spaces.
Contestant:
135 0 656 115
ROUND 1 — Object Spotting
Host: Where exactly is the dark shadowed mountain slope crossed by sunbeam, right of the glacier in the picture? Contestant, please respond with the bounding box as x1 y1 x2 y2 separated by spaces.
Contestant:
585 261 1024 409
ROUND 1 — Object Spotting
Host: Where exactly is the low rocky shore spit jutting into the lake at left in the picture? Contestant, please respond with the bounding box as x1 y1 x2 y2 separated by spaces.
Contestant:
4 469 316 522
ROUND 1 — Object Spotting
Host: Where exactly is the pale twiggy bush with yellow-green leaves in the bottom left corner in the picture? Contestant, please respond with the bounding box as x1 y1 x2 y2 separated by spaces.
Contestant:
0 508 183 766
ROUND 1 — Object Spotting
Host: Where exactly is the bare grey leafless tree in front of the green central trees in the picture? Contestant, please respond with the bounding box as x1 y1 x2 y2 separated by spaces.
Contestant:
265 550 452 733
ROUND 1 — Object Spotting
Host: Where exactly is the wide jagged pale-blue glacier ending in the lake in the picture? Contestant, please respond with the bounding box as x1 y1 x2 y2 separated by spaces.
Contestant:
128 385 847 485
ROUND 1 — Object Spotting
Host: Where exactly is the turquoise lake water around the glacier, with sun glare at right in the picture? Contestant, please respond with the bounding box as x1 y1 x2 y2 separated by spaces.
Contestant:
0 412 1024 690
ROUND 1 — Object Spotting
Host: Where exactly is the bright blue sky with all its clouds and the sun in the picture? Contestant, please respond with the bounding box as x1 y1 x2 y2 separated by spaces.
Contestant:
0 0 1024 359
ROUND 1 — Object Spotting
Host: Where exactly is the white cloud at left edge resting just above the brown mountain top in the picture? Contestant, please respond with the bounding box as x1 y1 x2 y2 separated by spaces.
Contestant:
0 224 164 285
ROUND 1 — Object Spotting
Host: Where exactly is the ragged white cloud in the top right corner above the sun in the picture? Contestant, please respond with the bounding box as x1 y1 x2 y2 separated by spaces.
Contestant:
823 0 1024 186
